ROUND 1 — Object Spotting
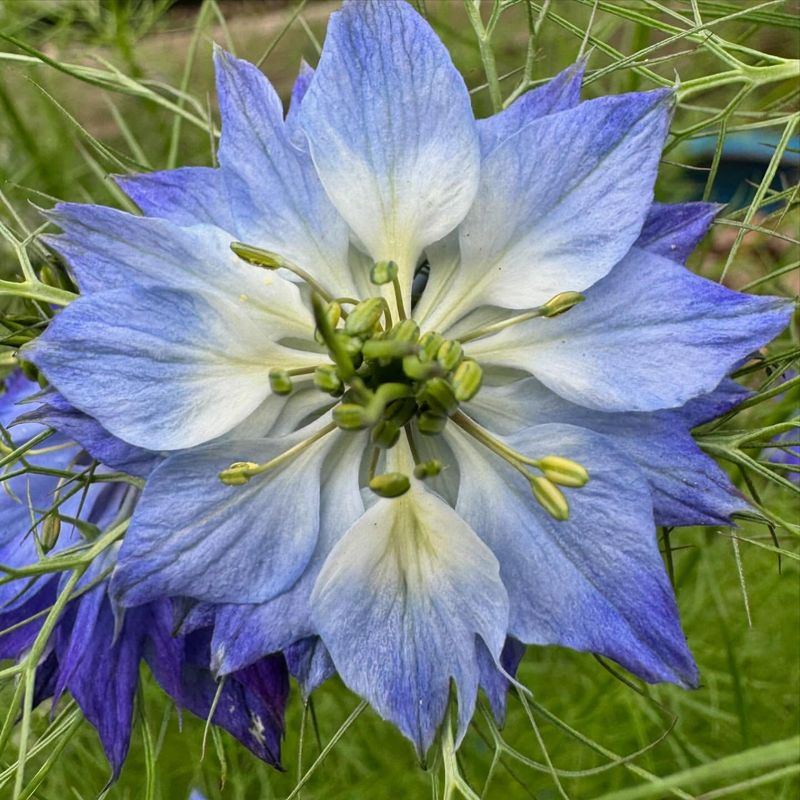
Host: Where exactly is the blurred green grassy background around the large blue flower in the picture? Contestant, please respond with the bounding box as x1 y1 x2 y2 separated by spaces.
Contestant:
0 0 800 800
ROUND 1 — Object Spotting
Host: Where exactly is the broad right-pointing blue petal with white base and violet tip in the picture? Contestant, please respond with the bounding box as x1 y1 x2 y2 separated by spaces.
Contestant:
467 248 793 411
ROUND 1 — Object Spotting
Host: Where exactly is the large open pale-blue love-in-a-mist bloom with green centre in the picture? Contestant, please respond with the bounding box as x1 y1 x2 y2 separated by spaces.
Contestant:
27 0 789 752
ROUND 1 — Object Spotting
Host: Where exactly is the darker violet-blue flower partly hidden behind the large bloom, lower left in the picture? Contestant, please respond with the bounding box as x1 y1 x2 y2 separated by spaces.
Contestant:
0 372 288 779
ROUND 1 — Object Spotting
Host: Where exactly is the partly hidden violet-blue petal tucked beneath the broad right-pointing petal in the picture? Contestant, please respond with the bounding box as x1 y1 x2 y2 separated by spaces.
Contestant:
469 378 748 525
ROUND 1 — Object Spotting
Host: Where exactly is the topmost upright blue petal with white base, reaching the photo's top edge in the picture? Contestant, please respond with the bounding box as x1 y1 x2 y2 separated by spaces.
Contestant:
301 0 479 302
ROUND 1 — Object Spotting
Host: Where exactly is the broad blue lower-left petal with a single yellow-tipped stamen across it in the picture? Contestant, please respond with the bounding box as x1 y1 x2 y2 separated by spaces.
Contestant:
112 426 340 606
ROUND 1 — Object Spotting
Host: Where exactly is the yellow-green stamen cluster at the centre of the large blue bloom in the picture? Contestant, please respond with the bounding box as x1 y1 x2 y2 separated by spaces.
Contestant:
220 243 589 520
